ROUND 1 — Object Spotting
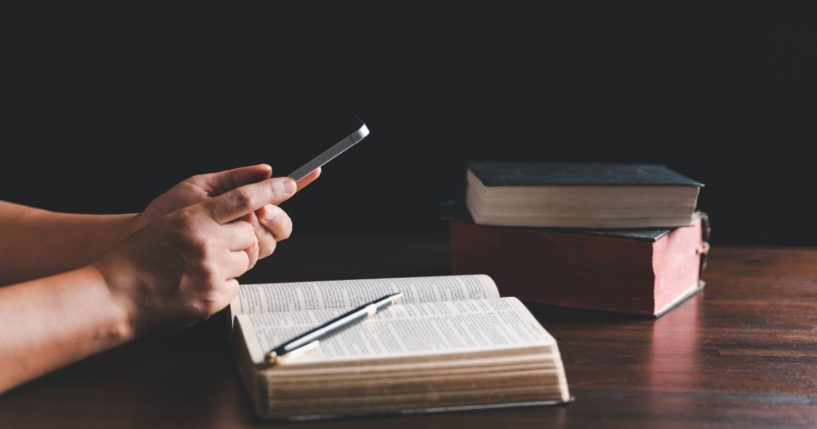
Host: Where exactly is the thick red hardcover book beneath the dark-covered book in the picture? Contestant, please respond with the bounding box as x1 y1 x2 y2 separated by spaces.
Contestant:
451 213 709 317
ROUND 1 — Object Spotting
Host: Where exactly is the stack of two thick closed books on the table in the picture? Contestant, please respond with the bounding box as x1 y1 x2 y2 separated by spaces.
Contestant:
451 162 709 317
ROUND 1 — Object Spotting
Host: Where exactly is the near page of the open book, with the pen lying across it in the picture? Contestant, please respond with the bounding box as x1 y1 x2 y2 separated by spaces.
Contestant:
237 298 555 365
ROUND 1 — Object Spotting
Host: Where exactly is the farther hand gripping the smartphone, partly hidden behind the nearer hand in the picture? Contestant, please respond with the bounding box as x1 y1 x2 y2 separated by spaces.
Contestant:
128 164 321 267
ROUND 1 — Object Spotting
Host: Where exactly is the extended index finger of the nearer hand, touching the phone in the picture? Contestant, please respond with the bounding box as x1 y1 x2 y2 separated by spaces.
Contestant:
200 177 297 223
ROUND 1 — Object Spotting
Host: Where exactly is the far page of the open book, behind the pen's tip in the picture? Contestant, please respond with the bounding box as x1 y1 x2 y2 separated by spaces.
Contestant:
230 275 499 314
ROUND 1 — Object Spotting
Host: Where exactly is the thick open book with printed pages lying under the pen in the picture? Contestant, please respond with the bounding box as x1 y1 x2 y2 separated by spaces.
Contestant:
230 275 570 419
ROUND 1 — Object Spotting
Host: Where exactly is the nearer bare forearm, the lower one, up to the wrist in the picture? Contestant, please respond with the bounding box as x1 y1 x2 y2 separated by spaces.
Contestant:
0 266 133 392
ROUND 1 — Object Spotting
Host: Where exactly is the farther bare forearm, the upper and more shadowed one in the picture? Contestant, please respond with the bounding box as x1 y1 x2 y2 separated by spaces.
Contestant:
0 201 136 285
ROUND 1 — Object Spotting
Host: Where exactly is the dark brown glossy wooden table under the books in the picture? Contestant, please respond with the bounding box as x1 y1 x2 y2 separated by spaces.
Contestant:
0 238 817 429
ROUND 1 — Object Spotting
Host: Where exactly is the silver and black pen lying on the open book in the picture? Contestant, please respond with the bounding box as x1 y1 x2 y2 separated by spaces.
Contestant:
265 292 403 365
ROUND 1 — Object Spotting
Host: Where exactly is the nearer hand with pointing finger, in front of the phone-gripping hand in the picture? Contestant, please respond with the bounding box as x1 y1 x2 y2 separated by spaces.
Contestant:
94 177 296 335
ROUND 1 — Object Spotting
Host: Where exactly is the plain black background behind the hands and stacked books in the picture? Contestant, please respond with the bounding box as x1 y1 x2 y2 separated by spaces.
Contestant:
0 2 817 245
